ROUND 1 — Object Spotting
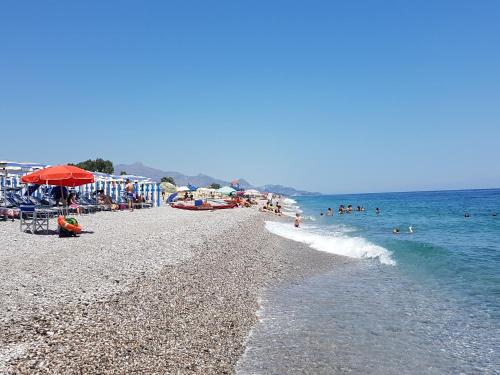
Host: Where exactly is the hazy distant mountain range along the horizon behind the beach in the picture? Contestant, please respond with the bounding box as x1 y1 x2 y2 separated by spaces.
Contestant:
115 162 319 196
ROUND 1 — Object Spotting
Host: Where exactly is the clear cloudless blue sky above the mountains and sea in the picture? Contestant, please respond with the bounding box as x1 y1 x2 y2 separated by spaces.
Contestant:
0 0 500 193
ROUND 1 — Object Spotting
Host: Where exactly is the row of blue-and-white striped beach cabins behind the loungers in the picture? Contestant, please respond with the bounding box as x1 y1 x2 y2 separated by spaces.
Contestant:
0 161 161 207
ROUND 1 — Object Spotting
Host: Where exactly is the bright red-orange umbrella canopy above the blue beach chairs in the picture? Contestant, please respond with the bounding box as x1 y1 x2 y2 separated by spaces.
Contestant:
21 165 94 187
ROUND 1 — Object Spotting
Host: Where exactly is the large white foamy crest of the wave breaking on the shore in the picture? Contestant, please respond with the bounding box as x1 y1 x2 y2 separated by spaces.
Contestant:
266 221 396 265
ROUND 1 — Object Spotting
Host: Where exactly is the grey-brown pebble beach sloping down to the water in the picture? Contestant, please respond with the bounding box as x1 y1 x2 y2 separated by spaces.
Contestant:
0 208 344 374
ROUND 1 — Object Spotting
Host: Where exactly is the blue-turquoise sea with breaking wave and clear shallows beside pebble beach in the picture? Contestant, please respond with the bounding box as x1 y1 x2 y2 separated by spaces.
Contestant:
237 189 500 375
